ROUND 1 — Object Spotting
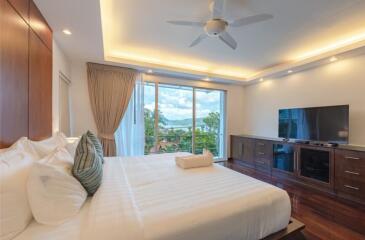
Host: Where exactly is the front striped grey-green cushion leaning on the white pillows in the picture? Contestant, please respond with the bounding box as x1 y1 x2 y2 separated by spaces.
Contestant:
72 134 103 196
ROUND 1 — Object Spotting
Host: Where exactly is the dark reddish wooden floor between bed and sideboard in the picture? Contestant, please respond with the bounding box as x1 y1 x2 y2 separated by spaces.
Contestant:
224 162 365 240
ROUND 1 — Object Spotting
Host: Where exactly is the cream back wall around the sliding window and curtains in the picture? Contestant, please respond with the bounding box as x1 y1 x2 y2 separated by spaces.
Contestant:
70 61 244 156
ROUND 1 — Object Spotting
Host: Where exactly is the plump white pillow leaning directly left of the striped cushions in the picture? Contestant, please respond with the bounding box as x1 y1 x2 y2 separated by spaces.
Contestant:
27 148 87 225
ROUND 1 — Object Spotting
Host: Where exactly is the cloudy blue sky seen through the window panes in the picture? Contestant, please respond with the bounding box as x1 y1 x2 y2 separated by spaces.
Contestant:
144 84 221 120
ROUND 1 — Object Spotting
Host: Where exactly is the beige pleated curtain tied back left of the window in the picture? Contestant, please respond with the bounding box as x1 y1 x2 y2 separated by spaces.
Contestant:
87 63 138 156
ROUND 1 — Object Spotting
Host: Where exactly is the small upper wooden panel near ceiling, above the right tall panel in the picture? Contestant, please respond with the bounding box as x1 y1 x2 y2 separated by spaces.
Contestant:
29 1 52 50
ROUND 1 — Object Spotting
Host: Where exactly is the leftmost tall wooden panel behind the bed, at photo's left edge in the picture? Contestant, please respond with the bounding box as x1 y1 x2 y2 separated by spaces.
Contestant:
0 0 29 148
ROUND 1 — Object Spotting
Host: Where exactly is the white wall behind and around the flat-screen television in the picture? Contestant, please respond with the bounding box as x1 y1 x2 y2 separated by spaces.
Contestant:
243 55 365 145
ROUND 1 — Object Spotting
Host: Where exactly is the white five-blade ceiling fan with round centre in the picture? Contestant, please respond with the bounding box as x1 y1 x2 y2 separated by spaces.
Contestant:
167 0 274 49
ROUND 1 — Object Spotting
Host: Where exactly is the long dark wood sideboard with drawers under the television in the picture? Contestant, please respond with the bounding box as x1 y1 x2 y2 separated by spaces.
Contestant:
230 135 365 204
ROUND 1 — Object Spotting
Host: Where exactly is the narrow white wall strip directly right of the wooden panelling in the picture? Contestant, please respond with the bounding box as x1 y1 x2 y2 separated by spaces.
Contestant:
52 40 71 133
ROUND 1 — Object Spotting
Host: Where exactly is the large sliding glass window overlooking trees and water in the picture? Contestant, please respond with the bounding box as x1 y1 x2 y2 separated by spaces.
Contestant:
144 83 225 158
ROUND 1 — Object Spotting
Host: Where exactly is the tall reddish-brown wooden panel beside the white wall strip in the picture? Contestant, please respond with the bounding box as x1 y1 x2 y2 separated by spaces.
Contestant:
29 31 52 140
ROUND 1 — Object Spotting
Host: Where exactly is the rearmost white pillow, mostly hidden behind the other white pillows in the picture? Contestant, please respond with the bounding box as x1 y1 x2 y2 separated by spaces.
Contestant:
31 132 67 158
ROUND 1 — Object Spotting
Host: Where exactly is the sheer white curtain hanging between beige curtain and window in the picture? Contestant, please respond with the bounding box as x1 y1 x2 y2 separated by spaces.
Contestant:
115 74 144 156
